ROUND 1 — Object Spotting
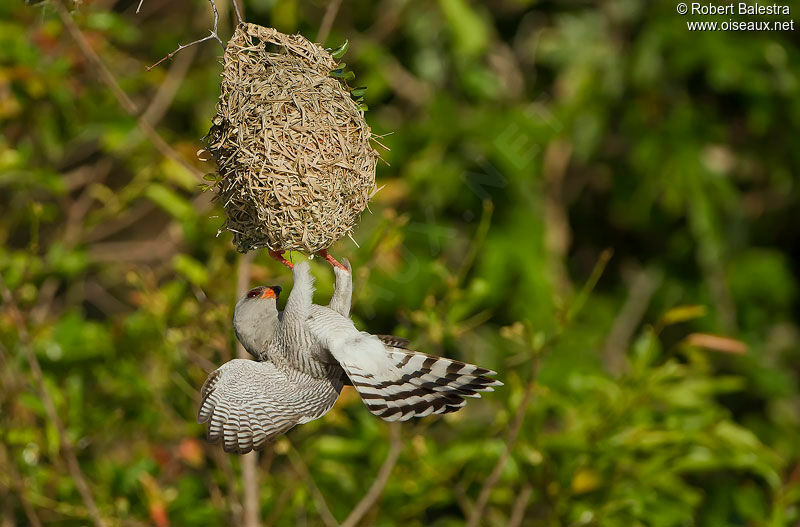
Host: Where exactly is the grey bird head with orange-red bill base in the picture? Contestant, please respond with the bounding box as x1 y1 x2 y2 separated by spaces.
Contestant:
233 286 281 359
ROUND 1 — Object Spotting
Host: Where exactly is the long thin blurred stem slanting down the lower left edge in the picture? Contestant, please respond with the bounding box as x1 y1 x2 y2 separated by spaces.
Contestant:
0 276 106 527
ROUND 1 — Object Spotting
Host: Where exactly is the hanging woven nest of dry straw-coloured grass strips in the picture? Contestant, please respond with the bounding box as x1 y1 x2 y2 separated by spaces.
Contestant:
208 24 378 252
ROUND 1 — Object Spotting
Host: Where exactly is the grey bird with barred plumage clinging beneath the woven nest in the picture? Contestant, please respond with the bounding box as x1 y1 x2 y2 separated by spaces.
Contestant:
197 261 502 453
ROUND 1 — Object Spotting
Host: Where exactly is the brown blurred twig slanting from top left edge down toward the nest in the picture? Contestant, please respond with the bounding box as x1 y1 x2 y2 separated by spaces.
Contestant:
53 1 203 179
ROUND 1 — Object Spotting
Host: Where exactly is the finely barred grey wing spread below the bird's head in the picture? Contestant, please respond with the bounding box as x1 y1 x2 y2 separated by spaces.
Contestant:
197 359 341 454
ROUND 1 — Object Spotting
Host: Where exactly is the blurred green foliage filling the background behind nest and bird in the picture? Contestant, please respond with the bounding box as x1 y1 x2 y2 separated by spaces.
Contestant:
0 0 800 527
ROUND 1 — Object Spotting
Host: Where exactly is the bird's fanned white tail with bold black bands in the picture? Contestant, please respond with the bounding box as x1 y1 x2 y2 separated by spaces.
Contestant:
308 309 502 421
